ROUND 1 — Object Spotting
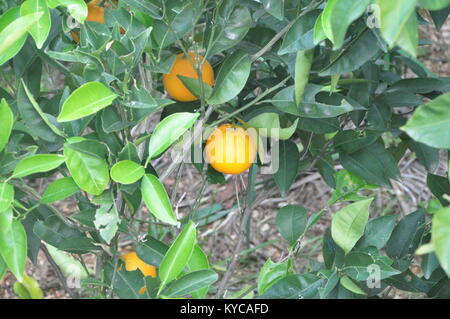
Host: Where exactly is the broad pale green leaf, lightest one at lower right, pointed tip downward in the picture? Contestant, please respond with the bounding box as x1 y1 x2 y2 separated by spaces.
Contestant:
331 198 373 254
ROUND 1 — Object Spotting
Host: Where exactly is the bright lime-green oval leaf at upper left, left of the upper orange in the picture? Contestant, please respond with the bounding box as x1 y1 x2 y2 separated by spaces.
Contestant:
58 82 117 122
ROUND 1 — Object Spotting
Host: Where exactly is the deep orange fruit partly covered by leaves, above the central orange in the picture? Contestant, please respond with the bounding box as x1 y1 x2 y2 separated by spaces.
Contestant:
163 52 214 102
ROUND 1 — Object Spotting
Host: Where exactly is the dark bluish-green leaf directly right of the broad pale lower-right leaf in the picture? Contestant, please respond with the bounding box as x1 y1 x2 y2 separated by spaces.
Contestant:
357 215 397 249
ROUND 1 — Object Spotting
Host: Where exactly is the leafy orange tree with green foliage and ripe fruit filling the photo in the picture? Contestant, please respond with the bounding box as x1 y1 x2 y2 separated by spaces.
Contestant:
0 0 450 298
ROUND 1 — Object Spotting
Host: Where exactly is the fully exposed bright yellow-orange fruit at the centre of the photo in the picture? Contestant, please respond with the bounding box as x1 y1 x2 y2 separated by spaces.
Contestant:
205 124 256 174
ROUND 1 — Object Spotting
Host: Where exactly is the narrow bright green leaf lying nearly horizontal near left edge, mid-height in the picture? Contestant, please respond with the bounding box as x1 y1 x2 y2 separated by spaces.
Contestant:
10 154 65 178
